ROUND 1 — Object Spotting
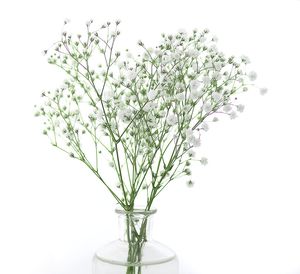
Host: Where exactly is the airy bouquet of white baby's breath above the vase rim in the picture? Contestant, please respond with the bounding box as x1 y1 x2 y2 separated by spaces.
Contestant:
36 21 266 211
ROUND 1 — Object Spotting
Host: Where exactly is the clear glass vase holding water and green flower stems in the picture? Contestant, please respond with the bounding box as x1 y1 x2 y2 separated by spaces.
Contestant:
93 209 178 274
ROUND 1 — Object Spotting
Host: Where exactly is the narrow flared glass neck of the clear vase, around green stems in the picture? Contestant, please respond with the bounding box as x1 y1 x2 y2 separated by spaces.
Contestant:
116 209 156 242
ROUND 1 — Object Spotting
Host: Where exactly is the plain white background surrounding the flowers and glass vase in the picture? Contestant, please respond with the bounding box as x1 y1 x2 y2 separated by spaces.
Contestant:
0 0 300 274
